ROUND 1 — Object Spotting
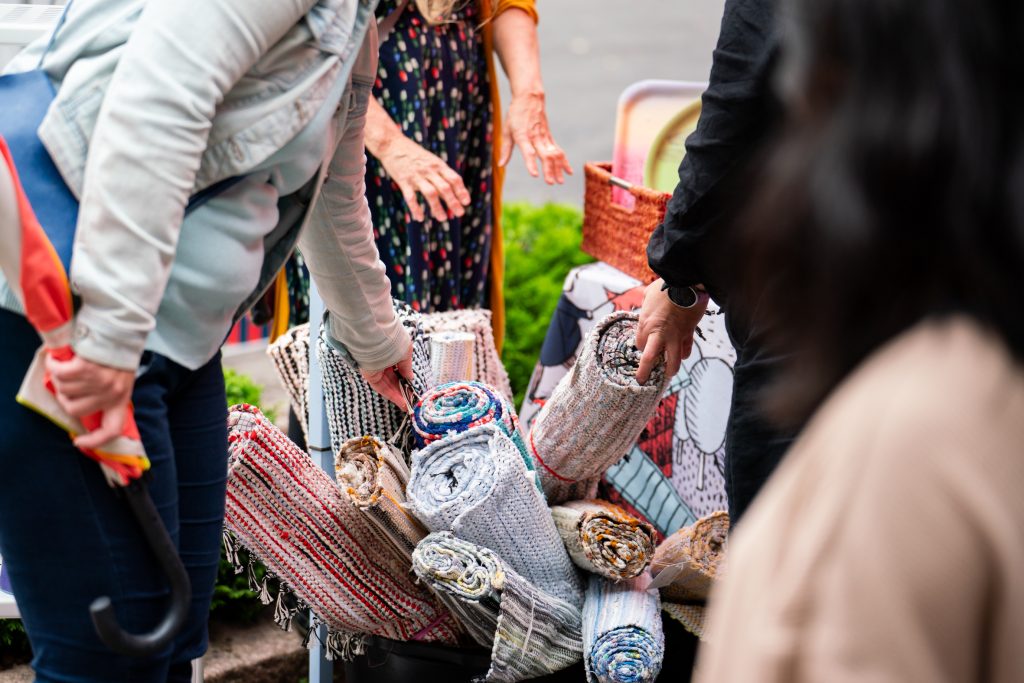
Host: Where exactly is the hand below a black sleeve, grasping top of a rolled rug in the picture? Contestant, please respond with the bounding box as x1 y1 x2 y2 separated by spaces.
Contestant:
637 280 708 384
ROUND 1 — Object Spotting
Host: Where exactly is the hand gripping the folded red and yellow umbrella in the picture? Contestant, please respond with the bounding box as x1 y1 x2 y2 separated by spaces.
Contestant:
46 355 135 450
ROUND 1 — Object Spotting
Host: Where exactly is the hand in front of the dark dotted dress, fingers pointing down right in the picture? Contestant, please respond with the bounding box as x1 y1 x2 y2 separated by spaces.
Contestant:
377 132 471 221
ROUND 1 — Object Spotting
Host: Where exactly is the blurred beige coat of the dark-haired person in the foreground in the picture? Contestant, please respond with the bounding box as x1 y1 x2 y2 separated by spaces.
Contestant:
696 318 1024 683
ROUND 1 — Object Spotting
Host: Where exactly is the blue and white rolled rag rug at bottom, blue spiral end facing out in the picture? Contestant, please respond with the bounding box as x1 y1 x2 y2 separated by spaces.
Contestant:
583 573 665 683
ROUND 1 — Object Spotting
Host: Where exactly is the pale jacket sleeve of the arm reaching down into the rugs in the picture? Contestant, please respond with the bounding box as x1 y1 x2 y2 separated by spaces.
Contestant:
299 26 411 371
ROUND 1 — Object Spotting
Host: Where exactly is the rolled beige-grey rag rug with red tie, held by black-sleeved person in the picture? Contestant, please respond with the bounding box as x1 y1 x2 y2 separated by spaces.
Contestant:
526 312 667 504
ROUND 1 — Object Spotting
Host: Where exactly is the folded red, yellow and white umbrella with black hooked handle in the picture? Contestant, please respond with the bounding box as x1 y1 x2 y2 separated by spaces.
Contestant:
0 135 191 655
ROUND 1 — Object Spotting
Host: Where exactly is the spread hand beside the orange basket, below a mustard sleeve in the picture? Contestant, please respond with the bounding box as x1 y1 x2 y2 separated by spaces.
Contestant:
500 92 572 185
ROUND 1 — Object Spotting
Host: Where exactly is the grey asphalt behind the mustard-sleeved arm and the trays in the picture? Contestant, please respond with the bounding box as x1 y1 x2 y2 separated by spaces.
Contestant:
503 0 724 206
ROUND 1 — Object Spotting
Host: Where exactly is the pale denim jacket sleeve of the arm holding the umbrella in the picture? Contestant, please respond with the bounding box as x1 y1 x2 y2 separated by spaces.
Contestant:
71 0 314 370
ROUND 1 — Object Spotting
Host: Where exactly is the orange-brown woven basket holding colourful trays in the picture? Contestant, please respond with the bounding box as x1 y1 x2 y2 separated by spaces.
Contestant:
581 163 672 283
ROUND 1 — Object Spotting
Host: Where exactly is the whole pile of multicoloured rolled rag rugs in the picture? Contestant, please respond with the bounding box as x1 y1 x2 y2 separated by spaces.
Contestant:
233 306 679 683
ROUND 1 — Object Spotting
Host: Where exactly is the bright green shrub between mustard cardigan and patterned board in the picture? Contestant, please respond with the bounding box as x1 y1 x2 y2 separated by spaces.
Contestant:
502 203 594 409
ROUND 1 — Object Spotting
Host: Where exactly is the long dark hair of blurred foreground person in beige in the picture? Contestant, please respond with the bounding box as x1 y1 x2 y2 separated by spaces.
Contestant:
740 0 1024 421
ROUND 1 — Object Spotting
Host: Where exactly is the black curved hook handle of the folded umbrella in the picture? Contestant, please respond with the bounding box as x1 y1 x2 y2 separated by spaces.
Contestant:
89 479 191 656
